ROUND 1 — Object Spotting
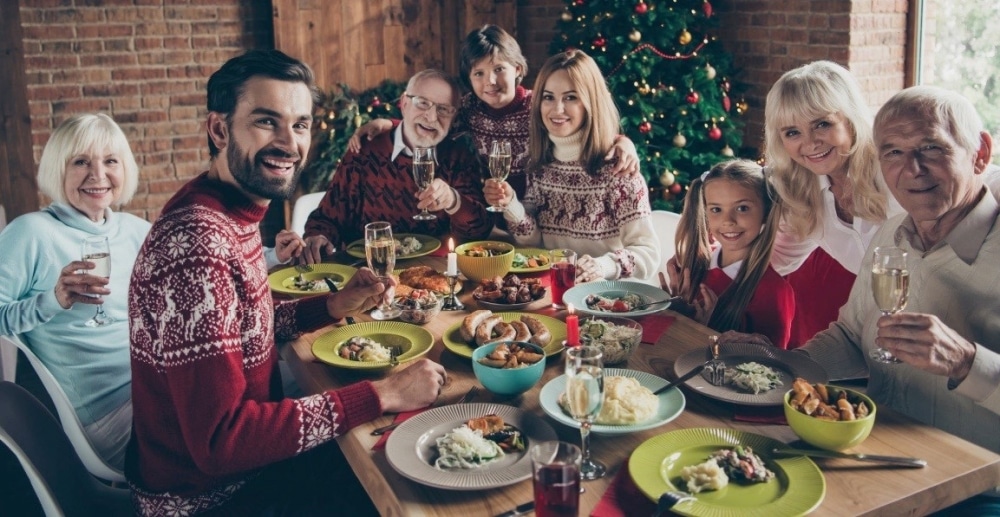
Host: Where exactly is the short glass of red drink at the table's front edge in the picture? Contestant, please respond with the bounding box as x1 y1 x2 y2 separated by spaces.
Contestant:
528 442 581 517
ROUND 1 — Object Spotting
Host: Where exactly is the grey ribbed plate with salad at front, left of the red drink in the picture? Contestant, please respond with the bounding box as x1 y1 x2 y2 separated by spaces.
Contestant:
385 403 559 490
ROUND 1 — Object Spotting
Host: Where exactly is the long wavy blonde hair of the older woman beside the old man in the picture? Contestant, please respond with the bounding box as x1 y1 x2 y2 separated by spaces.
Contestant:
764 61 888 238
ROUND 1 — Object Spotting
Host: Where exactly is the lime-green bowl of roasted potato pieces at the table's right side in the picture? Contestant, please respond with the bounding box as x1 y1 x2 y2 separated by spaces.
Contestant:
784 378 875 451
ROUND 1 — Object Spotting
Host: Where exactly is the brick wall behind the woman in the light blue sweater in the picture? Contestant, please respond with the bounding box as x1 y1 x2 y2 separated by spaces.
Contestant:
20 0 273 220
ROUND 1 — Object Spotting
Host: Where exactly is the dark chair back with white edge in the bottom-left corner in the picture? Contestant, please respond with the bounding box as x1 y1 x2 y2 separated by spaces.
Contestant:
0 381 133 517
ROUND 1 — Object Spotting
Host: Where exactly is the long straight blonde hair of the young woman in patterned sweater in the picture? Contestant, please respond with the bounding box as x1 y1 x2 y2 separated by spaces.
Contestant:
528 49 620 174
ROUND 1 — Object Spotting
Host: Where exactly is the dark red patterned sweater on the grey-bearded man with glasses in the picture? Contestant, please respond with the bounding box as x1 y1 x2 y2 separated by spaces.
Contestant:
304 121 493 249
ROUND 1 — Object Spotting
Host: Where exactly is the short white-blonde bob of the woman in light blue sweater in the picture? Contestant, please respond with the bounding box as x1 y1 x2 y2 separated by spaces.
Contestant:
37 113 139 206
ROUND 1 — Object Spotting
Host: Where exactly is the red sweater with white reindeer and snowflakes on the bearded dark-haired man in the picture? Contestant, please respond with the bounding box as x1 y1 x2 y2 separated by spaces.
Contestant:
125 174 381 515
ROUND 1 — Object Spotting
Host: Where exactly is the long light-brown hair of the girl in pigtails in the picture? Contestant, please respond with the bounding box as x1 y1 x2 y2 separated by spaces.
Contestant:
674 160 783 332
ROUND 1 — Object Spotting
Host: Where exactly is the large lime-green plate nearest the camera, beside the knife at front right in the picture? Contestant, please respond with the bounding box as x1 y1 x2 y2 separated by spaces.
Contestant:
628 428 826 517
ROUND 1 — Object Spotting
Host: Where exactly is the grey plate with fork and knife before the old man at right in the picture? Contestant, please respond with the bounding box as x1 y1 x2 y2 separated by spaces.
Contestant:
674 343 829 406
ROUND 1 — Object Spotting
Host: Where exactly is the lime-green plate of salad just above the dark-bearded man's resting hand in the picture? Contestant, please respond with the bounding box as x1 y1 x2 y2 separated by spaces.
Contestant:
313 321 434 370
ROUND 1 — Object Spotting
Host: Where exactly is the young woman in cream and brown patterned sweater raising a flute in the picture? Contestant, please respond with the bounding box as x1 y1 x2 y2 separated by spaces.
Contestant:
484 50 660 282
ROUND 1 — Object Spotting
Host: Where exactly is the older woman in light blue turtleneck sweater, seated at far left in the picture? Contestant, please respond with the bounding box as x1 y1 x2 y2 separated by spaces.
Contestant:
0 114 150 469
